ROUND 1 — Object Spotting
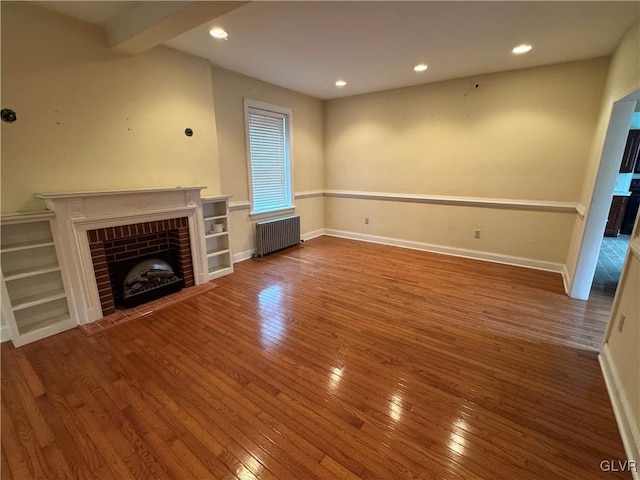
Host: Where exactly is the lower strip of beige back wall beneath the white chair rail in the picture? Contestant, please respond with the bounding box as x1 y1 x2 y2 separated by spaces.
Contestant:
325 198 573 263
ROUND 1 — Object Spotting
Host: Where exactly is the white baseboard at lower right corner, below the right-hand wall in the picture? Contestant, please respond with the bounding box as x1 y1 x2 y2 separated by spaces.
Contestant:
598 343 640 480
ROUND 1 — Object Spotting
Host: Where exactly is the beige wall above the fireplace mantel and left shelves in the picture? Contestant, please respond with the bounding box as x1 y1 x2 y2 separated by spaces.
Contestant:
2 2 220 212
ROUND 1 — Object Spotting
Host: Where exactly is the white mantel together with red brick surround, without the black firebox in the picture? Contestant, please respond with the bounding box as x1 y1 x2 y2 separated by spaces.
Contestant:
36 186 209 325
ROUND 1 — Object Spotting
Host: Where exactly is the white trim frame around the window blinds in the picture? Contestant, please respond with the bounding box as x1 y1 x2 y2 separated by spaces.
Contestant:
244 97 296 220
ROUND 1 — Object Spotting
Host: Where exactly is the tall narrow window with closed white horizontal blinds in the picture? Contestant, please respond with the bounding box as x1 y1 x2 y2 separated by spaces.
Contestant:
245 100 292 214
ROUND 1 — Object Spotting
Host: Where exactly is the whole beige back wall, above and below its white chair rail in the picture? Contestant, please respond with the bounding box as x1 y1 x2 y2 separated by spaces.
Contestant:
325 59 608 263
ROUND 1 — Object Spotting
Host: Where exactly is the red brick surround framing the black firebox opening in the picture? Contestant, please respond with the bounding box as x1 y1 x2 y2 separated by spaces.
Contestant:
87 217 194 316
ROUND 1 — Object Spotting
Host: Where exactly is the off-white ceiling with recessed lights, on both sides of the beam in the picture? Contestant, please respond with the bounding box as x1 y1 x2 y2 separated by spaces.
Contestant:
26 1 640 99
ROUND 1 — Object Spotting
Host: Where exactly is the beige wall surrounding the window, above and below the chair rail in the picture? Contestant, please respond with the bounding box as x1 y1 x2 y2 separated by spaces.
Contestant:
211 67 324 254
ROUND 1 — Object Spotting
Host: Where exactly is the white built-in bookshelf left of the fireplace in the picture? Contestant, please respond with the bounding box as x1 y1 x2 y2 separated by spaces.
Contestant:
0 216 75 347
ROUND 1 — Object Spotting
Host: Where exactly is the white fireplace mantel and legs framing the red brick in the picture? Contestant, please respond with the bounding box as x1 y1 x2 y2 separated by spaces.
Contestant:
36 186 209 325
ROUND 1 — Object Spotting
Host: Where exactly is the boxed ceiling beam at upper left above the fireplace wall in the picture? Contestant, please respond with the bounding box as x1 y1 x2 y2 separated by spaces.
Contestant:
107 1 249 55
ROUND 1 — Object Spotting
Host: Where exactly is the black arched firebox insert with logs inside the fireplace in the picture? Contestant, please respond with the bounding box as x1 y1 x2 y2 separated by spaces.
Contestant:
116 250 184 307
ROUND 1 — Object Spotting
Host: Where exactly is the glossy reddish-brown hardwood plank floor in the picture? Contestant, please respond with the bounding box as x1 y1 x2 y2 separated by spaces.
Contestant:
1 237 631 480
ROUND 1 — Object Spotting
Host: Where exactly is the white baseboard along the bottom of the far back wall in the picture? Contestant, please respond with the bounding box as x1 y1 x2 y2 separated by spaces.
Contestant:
324 228 566 276
